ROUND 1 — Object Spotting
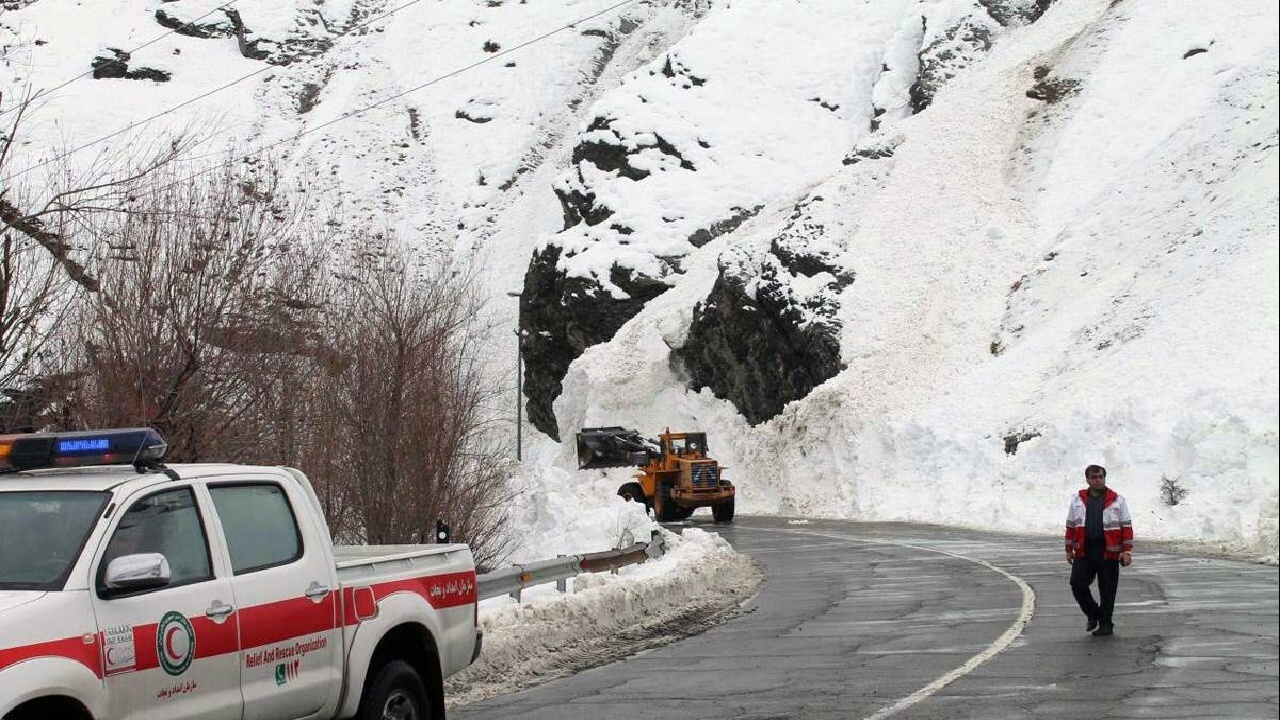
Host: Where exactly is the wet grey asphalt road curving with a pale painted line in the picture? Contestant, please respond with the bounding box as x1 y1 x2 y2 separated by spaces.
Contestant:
449 516 1280 720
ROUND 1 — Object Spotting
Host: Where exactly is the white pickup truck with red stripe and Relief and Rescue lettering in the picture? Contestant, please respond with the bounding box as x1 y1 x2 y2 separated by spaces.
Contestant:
0 429 481 720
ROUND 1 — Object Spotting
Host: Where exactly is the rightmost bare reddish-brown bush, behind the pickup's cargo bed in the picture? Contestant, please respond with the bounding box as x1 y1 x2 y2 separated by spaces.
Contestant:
308 236 511 565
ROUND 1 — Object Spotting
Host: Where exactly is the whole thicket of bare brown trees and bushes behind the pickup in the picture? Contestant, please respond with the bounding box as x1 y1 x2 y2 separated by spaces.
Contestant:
0 82 512 566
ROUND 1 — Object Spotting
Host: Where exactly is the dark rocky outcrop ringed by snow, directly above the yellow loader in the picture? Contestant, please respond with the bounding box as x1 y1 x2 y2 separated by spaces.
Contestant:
675 196 854 425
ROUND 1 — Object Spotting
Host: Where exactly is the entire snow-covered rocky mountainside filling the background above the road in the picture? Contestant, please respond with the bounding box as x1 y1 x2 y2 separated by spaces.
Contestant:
0 0 1280 557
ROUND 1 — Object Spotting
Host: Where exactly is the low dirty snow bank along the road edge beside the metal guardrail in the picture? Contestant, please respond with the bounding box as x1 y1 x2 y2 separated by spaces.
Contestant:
445 528 763 706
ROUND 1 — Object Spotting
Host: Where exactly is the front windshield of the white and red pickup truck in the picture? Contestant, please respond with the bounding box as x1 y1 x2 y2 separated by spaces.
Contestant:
0 491 109 591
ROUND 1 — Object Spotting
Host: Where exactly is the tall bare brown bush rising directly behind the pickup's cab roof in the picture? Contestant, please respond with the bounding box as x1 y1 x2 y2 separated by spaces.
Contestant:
62 151 326 461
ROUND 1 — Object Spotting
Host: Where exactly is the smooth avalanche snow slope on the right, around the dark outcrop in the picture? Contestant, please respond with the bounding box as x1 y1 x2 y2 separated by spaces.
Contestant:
545 3 1277 556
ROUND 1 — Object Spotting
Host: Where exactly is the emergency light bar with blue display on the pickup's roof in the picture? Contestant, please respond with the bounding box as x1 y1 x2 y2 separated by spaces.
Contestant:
0 428 169 473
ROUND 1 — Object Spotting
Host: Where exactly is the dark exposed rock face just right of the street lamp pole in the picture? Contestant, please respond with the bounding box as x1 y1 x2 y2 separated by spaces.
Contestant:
520 245 669 441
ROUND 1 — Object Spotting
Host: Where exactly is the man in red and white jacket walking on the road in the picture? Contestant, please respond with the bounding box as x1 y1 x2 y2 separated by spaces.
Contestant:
1066 465 1133 637
